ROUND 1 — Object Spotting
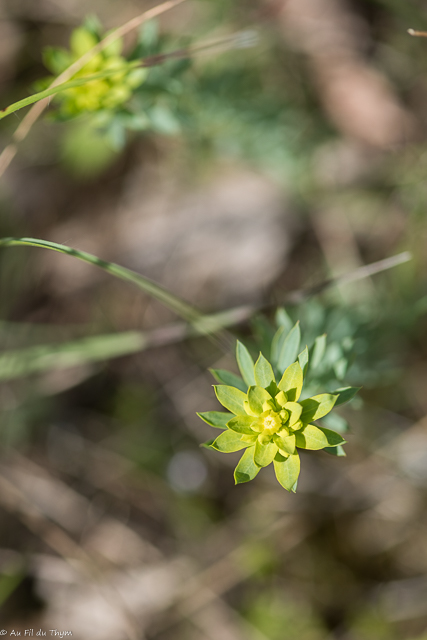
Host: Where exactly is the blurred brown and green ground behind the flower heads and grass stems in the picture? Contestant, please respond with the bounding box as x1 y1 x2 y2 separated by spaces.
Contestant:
0 0 427 640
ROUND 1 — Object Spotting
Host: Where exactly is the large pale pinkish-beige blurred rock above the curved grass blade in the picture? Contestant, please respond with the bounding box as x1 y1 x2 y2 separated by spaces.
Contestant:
117 167 294 307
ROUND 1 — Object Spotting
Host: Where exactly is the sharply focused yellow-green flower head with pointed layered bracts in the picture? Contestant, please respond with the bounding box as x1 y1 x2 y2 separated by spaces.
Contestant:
198 340 357 492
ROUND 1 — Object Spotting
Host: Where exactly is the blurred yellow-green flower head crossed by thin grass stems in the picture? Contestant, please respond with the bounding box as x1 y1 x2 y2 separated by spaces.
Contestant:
39 27 147 118
